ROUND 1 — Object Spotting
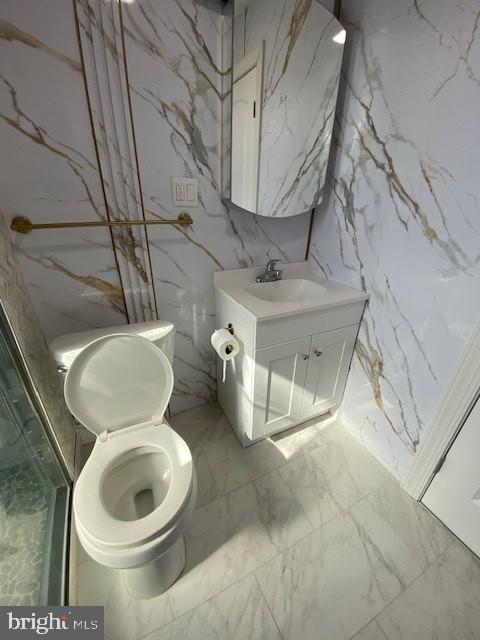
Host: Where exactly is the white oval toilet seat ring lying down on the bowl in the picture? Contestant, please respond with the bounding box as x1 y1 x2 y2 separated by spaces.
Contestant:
74 423 193 548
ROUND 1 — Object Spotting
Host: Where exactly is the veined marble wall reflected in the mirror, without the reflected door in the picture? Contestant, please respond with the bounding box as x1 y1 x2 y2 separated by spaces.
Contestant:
232 0 343 217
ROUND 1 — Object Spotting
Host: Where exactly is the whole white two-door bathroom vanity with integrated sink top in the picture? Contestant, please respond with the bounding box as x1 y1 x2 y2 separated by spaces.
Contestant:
214 262 368 446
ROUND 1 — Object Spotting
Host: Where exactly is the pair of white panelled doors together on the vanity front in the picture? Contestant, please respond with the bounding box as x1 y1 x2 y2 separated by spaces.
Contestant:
252 325 357 440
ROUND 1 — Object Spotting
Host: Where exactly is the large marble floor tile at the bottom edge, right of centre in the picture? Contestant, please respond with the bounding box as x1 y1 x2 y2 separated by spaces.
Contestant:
256 504 410 640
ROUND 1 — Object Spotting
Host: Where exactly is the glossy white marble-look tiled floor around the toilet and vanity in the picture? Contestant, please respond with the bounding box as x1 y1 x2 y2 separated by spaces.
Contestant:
78 405 480 640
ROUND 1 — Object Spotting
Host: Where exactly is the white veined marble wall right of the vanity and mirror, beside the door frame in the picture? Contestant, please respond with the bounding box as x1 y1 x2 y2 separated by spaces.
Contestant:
310 0 480 478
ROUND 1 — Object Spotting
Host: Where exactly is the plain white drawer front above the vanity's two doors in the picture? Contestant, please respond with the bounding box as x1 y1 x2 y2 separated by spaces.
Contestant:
255 302 365 349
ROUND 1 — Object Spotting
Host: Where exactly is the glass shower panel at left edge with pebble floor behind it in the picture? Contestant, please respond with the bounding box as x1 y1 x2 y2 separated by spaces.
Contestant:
0 306 70 605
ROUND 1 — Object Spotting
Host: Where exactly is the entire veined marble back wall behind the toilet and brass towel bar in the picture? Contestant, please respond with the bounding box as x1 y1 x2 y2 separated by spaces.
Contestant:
0 0 309 412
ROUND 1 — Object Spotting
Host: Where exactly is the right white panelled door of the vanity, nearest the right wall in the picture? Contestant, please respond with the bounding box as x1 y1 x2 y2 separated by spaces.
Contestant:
302 325 358 419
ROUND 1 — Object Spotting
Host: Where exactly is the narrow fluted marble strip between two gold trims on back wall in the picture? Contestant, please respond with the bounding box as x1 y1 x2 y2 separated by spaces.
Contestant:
75 0 157 322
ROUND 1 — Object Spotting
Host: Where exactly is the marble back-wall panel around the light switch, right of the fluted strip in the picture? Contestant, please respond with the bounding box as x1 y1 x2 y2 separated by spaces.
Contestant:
122 0 309 413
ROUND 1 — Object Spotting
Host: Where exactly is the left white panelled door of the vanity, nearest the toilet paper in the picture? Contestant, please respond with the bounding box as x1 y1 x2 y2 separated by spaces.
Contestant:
252 337 311 440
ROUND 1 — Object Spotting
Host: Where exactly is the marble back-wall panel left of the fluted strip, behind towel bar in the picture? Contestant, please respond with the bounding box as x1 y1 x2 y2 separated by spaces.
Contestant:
0 0 126 339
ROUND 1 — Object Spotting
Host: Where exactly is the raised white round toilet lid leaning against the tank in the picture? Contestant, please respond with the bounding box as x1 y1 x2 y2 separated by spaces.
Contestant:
64 333 173 435
